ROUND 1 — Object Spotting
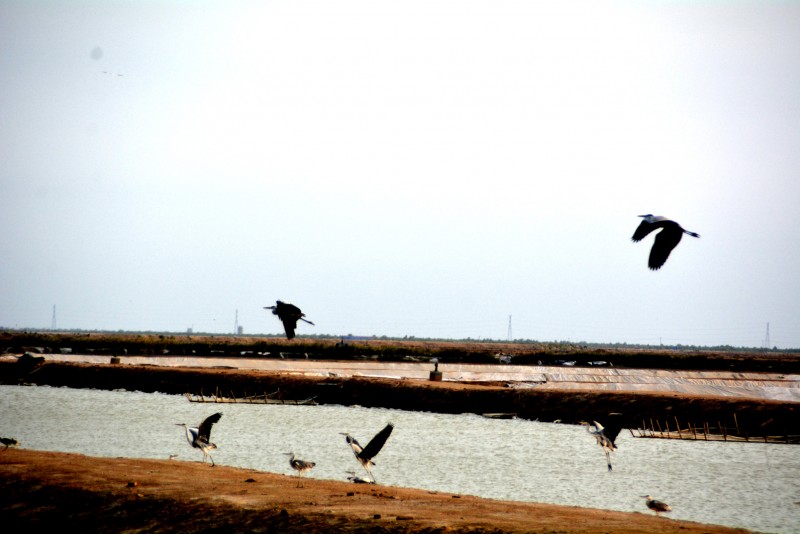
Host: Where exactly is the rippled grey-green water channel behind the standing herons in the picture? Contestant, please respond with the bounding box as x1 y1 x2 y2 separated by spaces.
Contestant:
0 386 800 533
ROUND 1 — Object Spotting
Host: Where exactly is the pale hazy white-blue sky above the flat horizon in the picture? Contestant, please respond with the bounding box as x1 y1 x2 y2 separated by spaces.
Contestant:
0 0 800 348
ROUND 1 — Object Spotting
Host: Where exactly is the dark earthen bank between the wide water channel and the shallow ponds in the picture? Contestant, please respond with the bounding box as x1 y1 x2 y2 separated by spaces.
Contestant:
0 358 800 437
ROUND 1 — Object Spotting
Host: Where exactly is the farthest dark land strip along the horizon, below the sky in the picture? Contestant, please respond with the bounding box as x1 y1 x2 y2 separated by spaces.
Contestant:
6 331 800 374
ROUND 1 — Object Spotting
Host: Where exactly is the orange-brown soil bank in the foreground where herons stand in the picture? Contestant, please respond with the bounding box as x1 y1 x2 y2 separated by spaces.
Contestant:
0 449 746 534
